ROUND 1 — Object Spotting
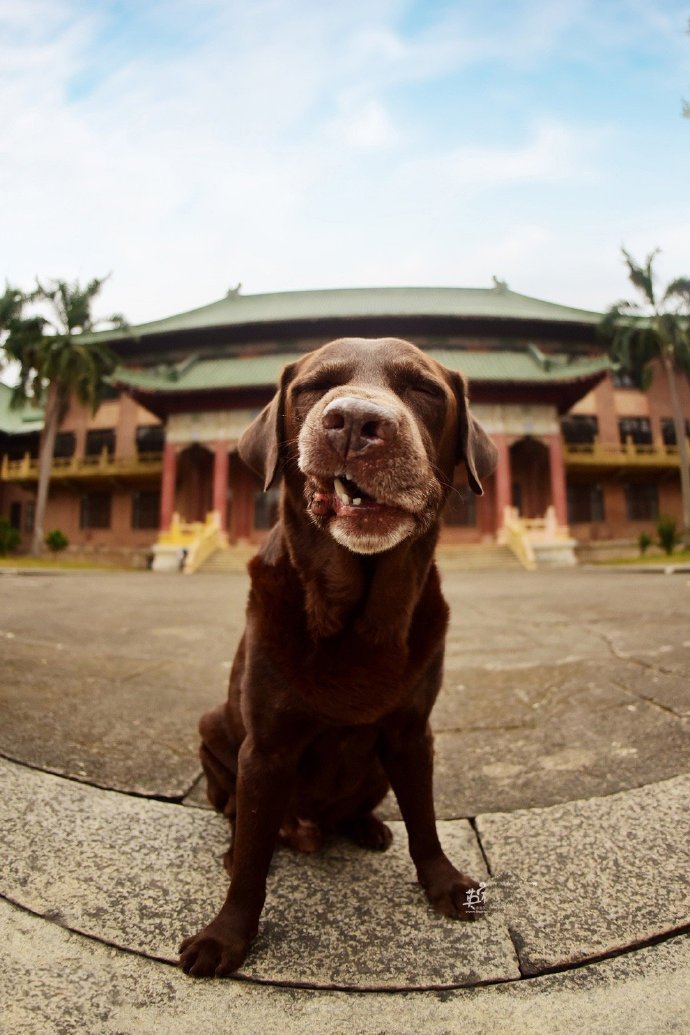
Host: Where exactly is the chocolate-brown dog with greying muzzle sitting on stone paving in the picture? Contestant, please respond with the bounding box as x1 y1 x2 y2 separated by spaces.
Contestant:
181 338 496 977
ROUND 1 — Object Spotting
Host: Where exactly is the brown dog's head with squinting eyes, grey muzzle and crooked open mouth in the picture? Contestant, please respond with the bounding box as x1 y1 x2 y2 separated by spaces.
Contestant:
239 337 497 554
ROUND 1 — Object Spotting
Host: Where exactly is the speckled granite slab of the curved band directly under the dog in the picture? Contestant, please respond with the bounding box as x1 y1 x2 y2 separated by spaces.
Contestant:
0 762 519 990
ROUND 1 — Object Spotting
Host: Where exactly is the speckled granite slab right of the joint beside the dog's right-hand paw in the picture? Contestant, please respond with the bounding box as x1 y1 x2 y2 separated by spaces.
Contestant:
477 775 690 974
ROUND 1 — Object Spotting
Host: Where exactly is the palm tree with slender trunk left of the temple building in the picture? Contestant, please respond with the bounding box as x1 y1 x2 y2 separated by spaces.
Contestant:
0 277 126 556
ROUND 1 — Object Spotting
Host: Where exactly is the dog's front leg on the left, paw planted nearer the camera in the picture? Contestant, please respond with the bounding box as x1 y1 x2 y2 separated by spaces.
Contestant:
180 736 299 977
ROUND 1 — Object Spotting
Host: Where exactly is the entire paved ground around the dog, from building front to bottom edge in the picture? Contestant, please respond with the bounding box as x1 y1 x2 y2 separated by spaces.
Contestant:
0 570 690 1033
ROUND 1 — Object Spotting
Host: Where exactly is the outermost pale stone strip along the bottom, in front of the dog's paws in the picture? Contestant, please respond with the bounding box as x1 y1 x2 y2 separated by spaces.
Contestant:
0 901 690 1035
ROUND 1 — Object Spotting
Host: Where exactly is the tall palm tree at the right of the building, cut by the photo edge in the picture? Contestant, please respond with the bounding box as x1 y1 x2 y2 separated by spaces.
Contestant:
600 248 690 546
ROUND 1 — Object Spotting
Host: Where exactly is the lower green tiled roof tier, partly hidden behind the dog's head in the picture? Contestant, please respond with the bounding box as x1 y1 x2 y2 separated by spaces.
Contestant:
113 346 609 394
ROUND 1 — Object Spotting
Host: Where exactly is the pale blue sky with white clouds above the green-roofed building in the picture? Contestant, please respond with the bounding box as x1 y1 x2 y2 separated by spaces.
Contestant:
0 0 690 324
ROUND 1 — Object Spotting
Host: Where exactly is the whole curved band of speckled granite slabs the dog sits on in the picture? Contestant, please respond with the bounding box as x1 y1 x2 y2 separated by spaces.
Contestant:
0 762 690 990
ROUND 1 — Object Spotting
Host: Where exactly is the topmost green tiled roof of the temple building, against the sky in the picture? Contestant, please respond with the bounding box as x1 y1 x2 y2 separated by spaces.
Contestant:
98 283 601 339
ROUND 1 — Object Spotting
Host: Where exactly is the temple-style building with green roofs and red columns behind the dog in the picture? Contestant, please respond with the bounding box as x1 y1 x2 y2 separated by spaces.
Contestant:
0 282 690 564
